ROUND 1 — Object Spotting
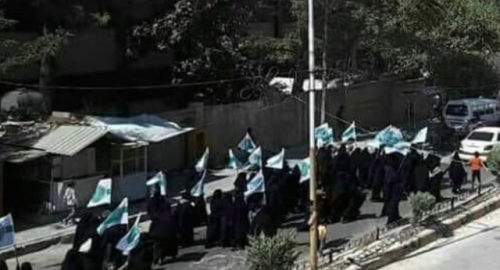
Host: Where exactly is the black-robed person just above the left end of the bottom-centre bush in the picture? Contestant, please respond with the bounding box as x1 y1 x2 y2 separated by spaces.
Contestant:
233 192 250 249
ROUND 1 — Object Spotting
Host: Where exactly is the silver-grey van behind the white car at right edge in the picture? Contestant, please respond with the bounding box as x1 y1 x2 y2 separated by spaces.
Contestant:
443 98 500 135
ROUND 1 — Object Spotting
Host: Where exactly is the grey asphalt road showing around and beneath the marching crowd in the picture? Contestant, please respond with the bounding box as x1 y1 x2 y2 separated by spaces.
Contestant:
8 169 500 270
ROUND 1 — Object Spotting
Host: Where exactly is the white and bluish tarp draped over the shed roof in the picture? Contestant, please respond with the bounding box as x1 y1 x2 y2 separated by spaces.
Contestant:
89 114 193 143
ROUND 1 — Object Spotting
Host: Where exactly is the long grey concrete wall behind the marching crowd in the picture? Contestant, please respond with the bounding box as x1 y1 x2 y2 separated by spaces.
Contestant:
160 78 431 166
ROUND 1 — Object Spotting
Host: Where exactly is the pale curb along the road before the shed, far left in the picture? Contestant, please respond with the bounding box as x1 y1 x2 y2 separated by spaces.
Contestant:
0 213 149 260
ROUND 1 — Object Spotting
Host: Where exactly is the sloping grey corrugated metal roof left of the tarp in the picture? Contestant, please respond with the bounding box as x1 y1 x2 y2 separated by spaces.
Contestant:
33 126 108 156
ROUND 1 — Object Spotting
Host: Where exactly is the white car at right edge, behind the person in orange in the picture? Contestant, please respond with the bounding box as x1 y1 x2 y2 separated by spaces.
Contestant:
459 127 500 161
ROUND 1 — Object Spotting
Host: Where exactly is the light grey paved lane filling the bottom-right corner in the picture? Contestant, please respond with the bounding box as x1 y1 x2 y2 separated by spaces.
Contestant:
382 204 500 270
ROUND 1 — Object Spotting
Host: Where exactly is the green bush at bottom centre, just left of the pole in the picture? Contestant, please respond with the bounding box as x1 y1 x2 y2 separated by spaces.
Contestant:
247 232 299 270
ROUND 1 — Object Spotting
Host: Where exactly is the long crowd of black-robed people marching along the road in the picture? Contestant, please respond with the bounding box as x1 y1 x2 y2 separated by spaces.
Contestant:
0 140 474 270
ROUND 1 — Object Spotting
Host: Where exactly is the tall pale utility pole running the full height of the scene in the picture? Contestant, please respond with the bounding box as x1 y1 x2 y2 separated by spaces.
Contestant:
308 0 318 270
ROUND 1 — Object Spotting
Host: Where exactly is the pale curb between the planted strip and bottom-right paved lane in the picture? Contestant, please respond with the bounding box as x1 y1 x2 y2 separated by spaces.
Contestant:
360 196 500 270
